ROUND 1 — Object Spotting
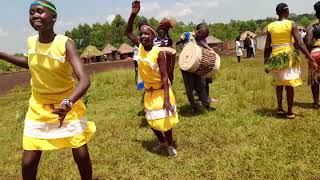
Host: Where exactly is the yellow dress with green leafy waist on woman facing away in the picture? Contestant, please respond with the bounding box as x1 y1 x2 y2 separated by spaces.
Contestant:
267 20 302 87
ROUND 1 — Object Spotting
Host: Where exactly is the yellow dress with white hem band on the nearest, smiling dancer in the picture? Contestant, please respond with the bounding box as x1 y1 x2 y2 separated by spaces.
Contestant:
23 35 96 150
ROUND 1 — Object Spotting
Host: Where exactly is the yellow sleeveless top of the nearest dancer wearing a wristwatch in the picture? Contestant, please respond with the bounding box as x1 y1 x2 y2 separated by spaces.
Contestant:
28 35 76 104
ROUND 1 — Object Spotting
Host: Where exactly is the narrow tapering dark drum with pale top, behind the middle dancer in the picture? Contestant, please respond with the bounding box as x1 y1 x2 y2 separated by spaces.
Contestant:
160 47 177 84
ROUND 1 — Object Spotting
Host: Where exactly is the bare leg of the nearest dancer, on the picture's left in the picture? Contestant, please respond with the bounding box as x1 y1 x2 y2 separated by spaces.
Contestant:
22 151 42 180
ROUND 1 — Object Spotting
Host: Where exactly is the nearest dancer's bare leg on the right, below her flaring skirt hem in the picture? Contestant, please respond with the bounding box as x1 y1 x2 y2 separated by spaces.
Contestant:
72 144 92 180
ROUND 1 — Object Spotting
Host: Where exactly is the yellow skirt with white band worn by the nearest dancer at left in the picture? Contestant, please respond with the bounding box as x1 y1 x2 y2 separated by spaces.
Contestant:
23 97 96 150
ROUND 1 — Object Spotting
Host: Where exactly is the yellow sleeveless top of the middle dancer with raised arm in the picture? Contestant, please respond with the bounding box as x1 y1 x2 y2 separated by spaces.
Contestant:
138 44 162 89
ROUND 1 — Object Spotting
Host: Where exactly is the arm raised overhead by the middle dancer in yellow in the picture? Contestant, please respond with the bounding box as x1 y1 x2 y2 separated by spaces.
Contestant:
126 1 140 46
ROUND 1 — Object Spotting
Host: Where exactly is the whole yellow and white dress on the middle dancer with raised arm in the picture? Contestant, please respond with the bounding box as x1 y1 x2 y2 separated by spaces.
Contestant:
138 44 179 132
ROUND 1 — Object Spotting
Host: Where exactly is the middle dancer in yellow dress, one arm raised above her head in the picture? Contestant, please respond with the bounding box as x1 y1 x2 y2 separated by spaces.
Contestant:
126 1 179 156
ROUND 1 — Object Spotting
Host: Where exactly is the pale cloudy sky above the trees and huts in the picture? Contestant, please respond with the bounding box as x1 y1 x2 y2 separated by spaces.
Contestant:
0 0 316 53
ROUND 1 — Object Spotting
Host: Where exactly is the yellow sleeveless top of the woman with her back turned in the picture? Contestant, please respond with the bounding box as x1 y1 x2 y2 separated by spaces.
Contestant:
268 20 294 56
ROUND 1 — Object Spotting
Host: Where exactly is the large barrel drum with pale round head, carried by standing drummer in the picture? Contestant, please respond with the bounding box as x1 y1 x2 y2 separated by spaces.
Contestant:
179 43 220 78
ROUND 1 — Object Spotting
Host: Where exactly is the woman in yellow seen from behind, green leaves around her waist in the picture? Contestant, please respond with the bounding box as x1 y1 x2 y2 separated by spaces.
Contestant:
264 3 317 118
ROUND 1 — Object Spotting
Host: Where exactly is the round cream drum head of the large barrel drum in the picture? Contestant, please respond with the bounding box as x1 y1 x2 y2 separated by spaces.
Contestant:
179 43 202 72
